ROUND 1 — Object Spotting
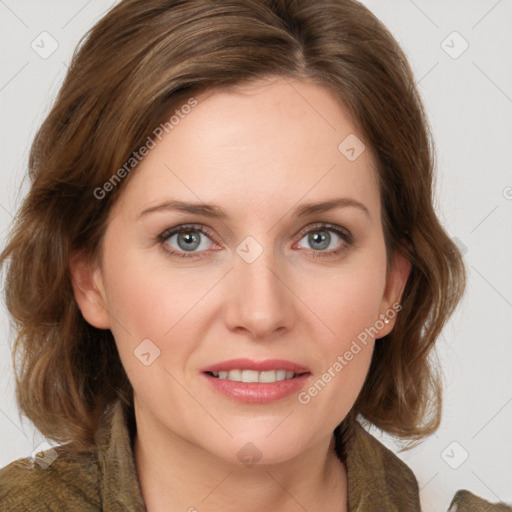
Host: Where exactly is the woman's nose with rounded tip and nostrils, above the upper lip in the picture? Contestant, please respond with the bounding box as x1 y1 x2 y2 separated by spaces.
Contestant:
225 244 296 340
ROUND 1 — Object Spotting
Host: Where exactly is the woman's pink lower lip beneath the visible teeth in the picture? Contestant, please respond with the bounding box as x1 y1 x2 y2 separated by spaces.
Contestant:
203 373 311 404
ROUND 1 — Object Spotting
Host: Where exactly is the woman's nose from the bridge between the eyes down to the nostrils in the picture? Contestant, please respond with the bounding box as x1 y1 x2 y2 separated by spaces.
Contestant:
227 237 293 338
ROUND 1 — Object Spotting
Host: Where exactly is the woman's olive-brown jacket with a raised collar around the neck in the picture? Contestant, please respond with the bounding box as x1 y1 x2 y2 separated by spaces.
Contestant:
0 402 512 512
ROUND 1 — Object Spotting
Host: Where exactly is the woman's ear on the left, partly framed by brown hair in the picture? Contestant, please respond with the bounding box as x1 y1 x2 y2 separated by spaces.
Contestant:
69 252 111 329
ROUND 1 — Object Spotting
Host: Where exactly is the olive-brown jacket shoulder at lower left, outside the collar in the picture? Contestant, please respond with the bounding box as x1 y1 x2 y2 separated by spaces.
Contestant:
0 445 101 512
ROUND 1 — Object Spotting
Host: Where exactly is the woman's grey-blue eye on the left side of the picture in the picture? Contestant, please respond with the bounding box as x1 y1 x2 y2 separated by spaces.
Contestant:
158 225 218 258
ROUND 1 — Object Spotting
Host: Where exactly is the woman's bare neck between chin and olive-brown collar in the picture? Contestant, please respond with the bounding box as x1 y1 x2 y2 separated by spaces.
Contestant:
134 400 347 512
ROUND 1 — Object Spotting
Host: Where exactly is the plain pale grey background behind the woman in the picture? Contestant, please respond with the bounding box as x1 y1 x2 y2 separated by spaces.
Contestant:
0 0 512 512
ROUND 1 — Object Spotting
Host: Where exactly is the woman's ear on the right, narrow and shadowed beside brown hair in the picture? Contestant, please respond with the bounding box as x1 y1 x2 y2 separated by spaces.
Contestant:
376 251 411 339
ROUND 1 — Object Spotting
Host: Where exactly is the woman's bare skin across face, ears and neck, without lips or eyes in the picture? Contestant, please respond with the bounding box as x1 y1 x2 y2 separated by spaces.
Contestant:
71 78 410 512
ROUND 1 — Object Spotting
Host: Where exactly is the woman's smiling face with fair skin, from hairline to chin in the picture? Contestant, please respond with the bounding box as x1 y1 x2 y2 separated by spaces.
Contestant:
75 79 403 463
